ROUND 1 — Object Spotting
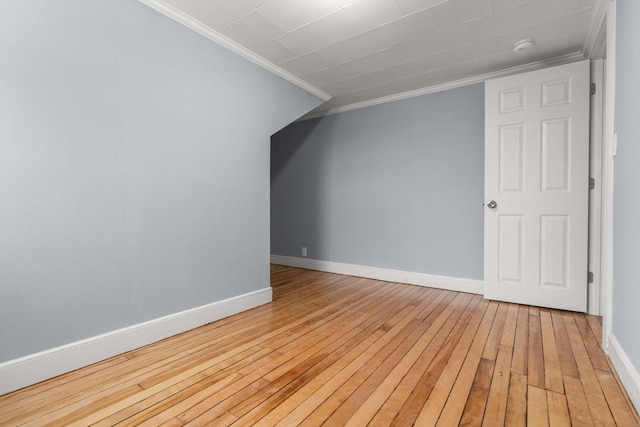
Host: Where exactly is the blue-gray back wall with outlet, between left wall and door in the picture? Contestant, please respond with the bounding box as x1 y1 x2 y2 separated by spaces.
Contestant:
271 84 484 279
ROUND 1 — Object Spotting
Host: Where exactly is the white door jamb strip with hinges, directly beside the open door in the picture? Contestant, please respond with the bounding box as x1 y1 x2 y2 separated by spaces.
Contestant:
587 59 604 316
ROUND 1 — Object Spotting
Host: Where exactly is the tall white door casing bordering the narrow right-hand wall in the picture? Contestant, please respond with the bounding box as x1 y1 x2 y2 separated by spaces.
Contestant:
600 0 616 351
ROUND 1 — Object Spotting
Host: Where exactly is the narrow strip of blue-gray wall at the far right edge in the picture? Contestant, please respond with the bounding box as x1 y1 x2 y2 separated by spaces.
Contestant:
612 0 640 371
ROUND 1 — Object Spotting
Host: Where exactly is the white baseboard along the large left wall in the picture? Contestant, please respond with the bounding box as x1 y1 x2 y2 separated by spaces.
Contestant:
0 287 272 395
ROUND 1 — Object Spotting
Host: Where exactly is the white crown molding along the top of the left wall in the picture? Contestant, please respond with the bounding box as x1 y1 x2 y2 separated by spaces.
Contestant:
139 0 331 101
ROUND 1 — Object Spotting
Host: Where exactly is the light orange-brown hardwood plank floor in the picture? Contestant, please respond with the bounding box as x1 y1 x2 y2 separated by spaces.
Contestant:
0 266 640 426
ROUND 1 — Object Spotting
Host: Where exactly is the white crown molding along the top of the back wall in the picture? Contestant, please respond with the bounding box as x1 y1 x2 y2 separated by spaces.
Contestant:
298 52 585 121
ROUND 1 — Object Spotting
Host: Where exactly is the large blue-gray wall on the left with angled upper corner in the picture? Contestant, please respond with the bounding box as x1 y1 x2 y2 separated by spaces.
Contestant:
0 0 320 361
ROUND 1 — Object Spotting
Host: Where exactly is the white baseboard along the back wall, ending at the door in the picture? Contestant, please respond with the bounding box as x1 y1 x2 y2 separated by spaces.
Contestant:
271 255 484 295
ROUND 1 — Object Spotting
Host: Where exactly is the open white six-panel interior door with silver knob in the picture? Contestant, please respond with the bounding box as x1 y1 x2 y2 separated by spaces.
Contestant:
484 61 590 312
